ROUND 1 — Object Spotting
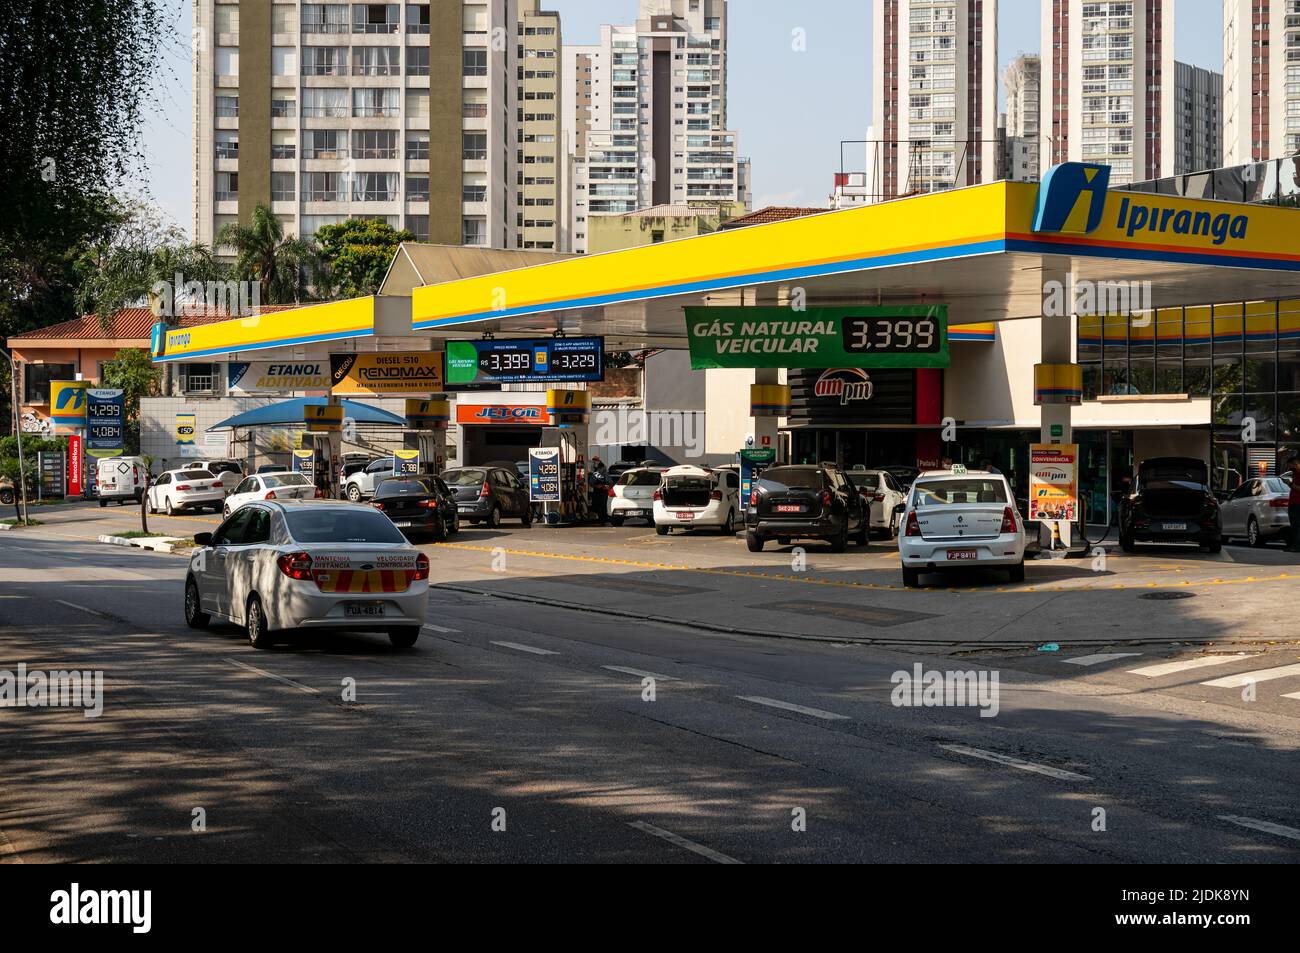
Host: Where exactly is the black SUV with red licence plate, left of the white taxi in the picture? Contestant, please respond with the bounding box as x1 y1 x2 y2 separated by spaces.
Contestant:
745 464 871 553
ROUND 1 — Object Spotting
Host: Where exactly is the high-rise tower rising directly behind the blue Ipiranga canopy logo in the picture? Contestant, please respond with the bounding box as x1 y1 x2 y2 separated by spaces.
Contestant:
1040 0 1177 185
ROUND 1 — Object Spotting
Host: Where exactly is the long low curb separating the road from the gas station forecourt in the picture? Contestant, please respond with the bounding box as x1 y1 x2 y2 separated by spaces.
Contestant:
430 582 1275 655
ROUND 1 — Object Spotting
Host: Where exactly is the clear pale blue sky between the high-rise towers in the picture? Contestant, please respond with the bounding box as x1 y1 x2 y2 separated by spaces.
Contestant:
137 0 1223 230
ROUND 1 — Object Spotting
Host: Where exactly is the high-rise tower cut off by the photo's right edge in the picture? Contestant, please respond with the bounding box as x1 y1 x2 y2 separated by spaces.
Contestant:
1223 0 1300 165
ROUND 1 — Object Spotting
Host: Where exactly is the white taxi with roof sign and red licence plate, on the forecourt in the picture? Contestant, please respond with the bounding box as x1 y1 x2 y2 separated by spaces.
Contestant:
898 467 1026 589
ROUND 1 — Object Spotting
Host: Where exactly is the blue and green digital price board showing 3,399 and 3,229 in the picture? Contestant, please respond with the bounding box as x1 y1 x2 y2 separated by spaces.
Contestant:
447 338 605 386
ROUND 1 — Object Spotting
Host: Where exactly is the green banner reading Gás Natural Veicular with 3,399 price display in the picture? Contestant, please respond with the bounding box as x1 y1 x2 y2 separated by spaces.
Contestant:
686 304 949 371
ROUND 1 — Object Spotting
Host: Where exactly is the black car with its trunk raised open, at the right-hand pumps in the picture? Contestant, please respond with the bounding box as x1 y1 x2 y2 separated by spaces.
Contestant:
1119 456 1223 553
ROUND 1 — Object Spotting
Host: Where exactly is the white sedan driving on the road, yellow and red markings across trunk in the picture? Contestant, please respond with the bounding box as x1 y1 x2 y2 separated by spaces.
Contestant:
185 499 429 649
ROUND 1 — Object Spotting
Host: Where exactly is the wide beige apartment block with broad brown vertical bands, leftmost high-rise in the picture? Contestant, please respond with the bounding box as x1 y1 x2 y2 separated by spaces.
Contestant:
194 0 517 248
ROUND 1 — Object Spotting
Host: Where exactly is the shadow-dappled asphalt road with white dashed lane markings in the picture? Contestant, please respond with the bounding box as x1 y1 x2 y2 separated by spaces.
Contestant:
0 514 1300 863
